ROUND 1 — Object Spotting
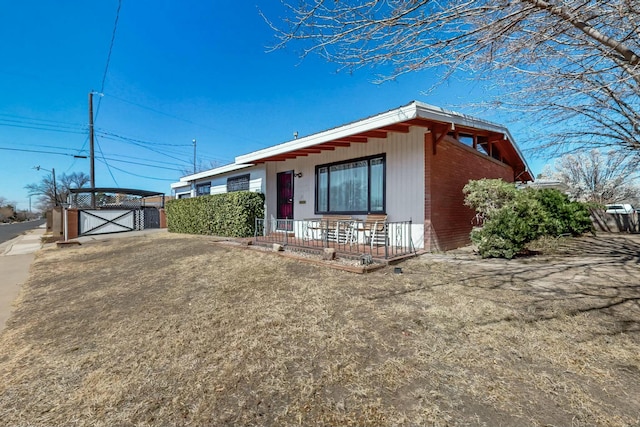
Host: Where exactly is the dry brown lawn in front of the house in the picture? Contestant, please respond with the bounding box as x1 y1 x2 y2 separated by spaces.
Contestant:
0 234 640 426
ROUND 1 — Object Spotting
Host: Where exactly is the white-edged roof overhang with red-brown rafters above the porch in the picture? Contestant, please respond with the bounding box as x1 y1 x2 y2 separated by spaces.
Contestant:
238 101 533 181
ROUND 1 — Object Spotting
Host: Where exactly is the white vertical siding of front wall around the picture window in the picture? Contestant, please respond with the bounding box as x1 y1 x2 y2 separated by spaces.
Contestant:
266 127 424 248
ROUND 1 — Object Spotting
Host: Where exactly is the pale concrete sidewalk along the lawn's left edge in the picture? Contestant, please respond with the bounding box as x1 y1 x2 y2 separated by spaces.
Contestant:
0 225 46 331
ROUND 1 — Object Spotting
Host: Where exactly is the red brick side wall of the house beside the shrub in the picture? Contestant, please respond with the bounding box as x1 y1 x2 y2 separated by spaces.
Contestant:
424 133 514 251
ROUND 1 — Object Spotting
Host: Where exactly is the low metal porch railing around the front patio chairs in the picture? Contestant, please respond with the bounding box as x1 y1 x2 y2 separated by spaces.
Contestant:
255 218 416 262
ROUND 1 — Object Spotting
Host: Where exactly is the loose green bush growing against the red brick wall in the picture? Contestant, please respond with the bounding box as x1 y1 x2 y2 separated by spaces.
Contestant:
463 179 592 259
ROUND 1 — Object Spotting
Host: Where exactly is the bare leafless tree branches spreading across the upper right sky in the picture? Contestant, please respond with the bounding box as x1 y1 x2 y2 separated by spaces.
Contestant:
265 0 640 155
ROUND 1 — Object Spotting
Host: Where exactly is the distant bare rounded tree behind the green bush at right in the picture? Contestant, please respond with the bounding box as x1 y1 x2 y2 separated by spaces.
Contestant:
543 150 640 205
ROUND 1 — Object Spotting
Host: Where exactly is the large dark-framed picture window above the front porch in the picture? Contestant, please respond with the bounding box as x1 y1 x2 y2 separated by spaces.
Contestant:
316 154 385 214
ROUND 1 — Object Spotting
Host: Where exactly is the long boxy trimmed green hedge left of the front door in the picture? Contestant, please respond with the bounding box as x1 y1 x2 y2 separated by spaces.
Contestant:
166 191 264 237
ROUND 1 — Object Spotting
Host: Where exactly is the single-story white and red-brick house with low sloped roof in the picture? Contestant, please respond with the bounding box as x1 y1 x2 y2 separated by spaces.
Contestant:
171 102 533 251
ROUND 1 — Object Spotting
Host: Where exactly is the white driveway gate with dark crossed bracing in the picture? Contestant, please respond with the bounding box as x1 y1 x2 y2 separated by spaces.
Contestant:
78 209 144 236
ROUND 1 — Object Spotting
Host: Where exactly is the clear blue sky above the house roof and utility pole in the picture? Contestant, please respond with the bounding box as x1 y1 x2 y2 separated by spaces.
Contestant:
0 0 543 209
